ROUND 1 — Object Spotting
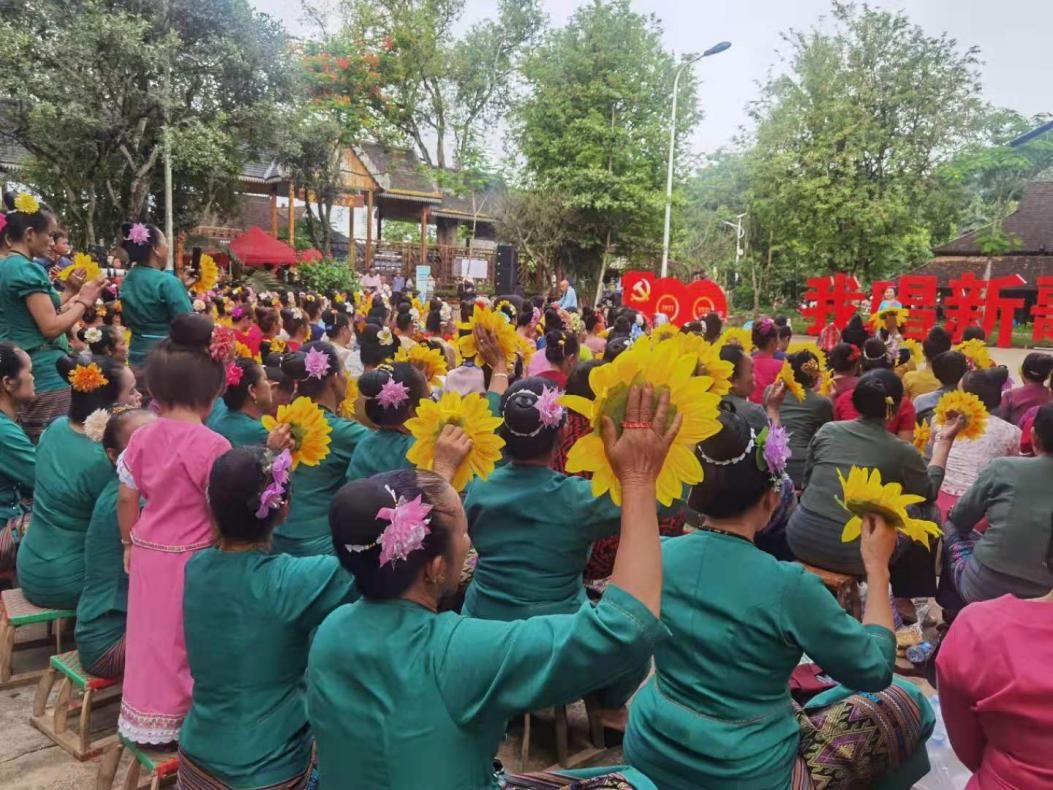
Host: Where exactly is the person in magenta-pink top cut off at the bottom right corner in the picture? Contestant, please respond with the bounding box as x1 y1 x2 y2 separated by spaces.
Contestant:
936 598 1053 790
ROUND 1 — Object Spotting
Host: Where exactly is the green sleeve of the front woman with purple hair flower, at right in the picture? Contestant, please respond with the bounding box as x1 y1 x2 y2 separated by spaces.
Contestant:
781 568 896 691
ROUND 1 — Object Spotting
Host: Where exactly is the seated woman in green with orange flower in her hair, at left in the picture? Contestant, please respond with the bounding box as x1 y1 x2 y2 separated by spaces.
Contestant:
18 357 140 609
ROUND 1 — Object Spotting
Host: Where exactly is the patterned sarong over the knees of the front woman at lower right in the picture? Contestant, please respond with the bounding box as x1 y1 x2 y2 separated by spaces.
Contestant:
791 684 923 790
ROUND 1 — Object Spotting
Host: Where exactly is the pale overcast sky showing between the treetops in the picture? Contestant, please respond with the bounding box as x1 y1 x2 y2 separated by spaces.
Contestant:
252 0 1053 154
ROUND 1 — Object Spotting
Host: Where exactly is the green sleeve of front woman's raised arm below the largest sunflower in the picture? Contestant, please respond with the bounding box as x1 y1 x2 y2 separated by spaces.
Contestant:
434 587 669 725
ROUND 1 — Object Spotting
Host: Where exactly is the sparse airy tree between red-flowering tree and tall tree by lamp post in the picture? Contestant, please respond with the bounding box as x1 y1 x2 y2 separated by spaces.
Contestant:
340 0 544 170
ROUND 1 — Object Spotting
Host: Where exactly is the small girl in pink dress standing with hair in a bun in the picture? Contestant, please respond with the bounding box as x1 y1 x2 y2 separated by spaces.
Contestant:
117 314 233 744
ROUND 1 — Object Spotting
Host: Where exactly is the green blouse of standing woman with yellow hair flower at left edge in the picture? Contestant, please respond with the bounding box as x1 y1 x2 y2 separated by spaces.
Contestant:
0 253 69 394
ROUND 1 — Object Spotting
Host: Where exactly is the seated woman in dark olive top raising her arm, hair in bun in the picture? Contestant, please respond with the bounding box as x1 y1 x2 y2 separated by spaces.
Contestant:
787 369 961 621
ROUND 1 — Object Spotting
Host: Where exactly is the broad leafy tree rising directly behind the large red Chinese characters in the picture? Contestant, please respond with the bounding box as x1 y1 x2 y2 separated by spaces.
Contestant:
749 2 982 277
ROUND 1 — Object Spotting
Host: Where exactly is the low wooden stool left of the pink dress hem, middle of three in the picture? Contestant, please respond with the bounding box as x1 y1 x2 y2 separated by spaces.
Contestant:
29 650 120 762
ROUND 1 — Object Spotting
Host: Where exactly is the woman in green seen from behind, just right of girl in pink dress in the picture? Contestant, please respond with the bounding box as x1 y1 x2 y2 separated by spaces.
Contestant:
179 447 356 790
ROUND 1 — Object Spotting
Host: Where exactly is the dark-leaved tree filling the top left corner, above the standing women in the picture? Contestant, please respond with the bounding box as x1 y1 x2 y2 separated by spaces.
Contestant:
0 0 289 242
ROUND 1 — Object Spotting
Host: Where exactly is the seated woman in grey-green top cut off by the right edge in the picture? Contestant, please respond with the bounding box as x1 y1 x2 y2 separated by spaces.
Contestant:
936 403 1053 612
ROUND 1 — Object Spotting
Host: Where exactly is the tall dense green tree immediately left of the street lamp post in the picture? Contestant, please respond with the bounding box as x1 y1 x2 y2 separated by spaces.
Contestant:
515 0 699 303
